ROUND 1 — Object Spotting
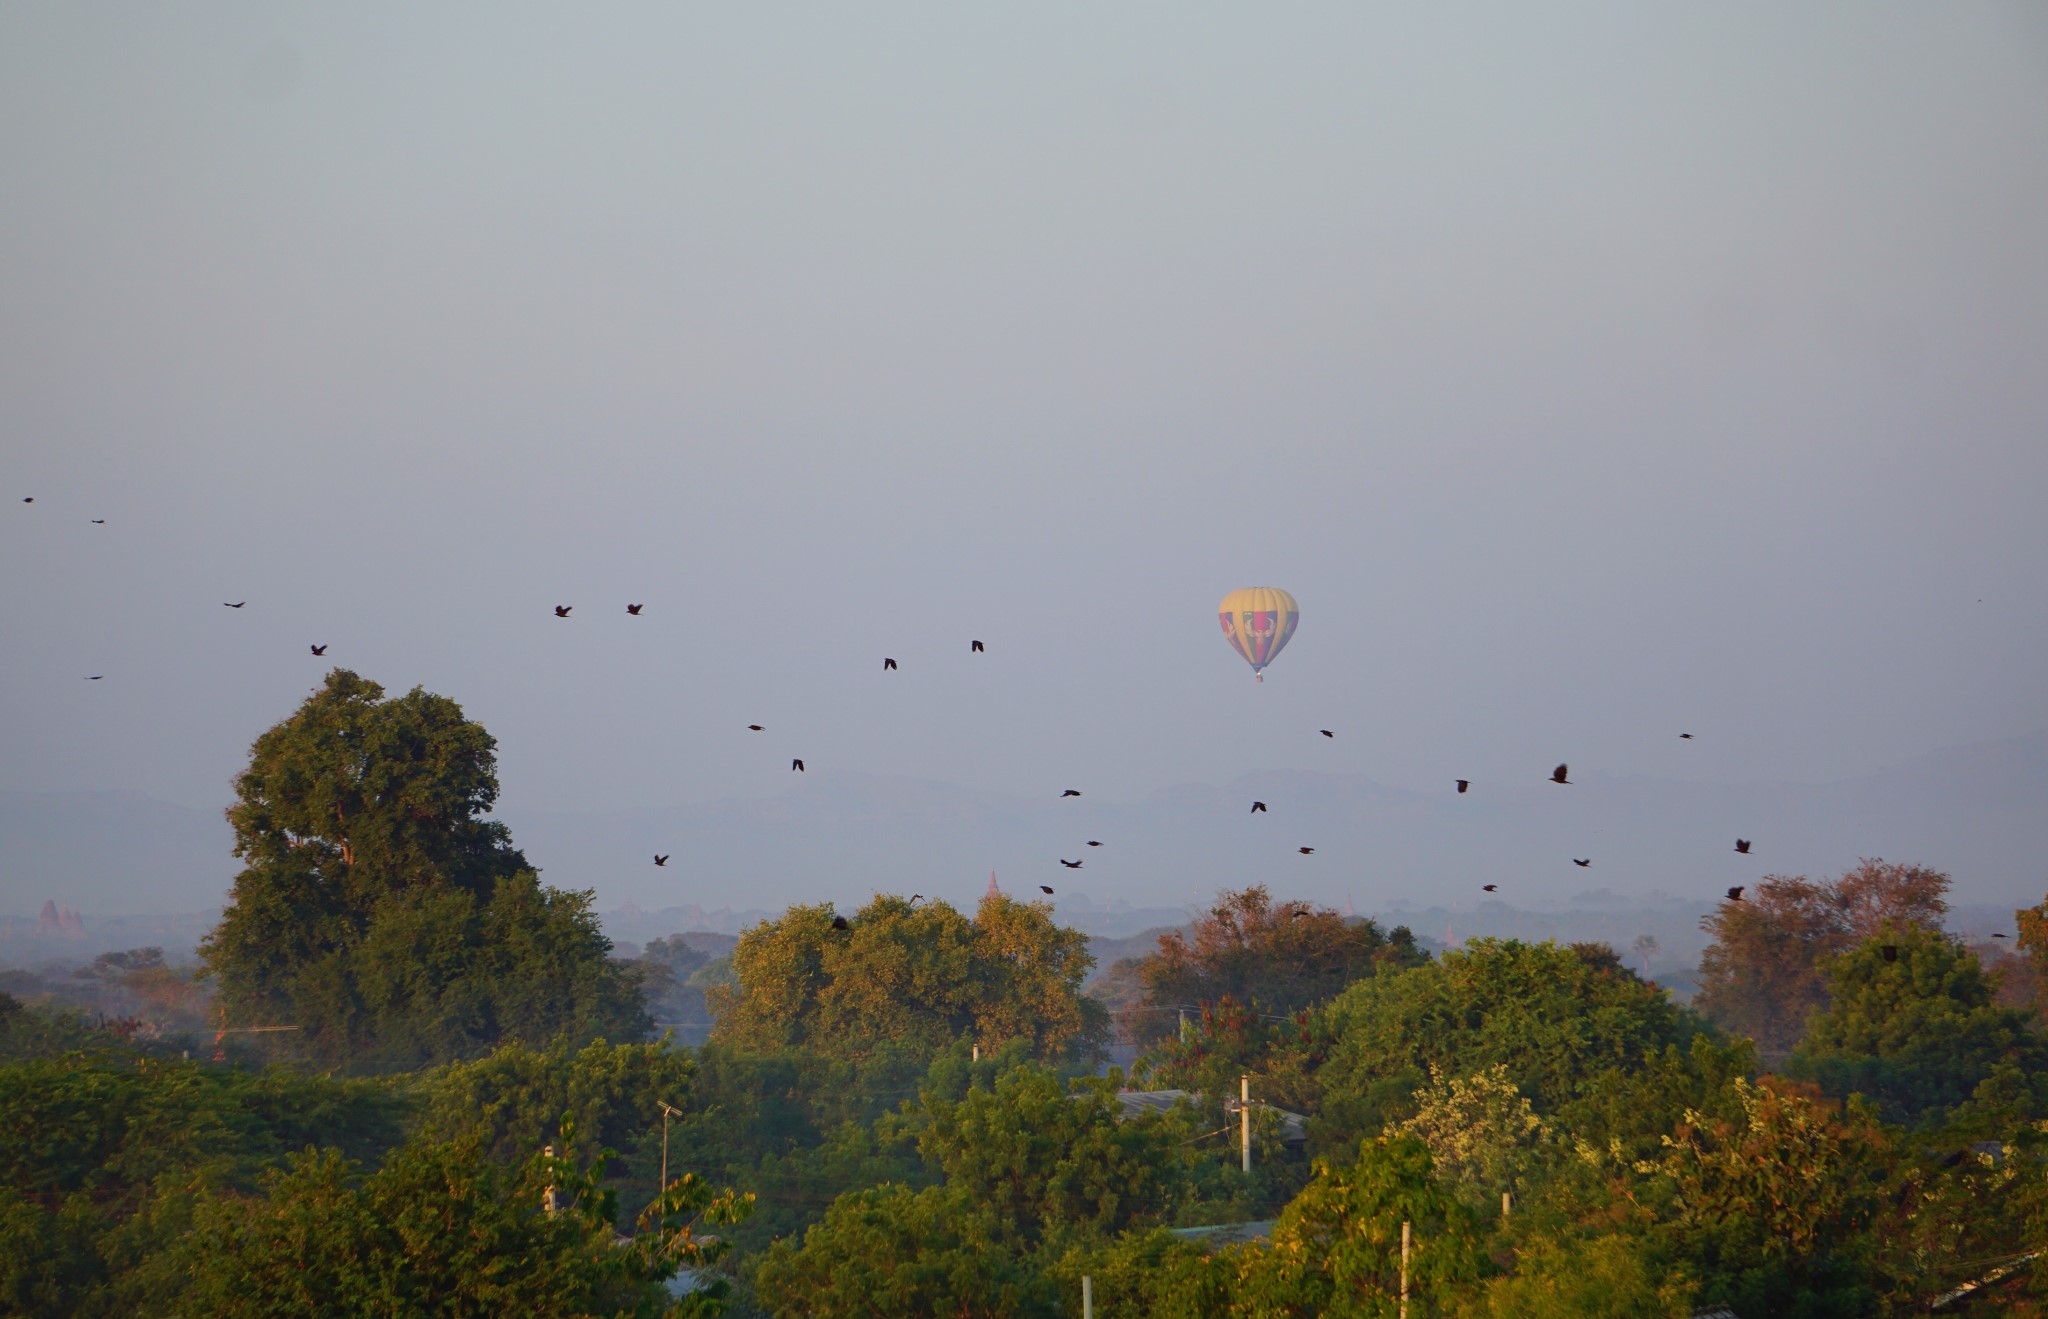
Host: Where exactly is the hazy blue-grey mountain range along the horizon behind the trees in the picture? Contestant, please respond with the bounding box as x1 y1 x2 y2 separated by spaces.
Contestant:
0 735 2048 942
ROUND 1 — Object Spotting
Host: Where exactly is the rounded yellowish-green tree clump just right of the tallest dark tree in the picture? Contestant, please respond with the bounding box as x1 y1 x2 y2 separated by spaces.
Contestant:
707 893 1108 1059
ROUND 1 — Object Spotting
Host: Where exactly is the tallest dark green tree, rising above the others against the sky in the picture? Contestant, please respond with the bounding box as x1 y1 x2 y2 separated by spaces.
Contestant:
203 670 647 1067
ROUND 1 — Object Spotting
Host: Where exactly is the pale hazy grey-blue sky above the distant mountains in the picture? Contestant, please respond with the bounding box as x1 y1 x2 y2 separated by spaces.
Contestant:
0 2 2048 905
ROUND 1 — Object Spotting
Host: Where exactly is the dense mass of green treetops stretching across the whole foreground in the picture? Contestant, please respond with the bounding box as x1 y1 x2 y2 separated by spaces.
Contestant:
19 852 2048 1319
